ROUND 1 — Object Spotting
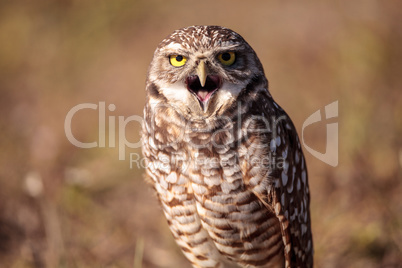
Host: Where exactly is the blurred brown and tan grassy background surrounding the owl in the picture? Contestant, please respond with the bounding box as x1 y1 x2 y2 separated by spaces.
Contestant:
0 0 402 268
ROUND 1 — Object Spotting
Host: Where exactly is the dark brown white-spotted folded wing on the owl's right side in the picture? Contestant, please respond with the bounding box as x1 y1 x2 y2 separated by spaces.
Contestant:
245 106 313 267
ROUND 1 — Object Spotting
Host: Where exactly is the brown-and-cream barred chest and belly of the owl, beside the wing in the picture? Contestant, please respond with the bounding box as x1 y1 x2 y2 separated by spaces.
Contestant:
148 120 281 266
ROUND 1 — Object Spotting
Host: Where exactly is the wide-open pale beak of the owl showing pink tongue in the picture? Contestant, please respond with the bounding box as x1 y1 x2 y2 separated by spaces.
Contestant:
186 60 221 111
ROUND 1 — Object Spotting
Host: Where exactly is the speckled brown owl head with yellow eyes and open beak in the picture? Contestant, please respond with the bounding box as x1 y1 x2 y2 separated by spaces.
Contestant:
147 26 267 118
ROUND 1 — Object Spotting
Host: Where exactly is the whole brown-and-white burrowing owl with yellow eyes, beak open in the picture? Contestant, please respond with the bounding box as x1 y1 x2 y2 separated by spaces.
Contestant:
143 26 313 267
